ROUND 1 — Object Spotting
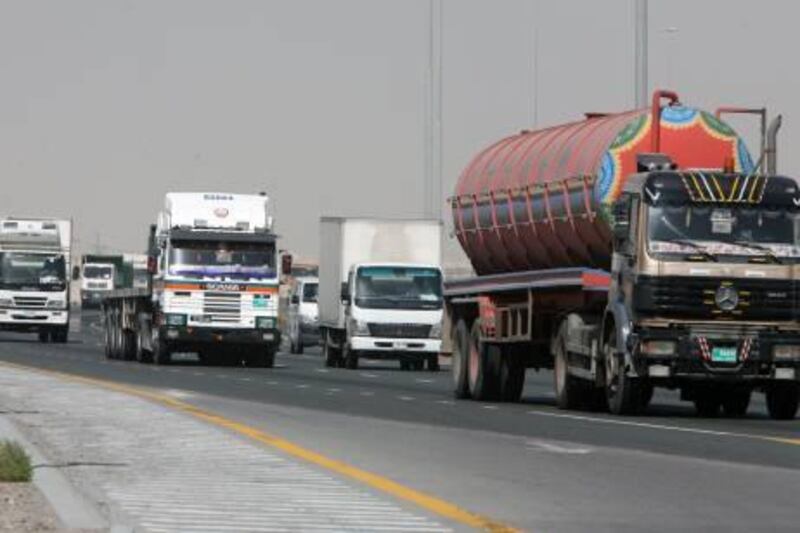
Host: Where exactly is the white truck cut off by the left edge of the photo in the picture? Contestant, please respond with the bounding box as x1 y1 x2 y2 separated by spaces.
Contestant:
0 218 72 343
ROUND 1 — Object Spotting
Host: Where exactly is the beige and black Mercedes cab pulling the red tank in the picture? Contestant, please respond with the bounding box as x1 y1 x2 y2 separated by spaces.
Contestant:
599 164 800 418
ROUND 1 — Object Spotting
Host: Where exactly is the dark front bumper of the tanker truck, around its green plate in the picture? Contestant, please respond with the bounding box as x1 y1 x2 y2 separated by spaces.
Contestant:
628 328 800 383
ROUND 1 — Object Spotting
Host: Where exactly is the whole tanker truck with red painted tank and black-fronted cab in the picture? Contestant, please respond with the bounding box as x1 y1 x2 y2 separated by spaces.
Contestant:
445 91 800 419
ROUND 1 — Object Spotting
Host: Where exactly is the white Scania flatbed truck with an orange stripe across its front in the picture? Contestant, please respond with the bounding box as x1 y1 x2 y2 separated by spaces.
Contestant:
102 193 280 367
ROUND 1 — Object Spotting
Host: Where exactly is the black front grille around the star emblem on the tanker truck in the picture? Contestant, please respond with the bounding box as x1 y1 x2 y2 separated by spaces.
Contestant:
634 276 800 320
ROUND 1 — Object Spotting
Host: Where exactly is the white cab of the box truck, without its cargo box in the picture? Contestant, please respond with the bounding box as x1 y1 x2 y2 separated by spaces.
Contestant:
342 263 443 370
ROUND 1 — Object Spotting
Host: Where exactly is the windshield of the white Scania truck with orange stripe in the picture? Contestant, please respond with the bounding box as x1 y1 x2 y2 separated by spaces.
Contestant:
169 241 277 280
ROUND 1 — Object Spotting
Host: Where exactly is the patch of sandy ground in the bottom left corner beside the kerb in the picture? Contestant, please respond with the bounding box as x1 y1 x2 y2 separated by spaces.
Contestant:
0 483 63 533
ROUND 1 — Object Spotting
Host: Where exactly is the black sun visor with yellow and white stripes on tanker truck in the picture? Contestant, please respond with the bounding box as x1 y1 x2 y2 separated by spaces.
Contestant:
642 171 800 209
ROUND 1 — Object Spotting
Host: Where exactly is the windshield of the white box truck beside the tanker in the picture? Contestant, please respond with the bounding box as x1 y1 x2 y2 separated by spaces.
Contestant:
355 266 442 309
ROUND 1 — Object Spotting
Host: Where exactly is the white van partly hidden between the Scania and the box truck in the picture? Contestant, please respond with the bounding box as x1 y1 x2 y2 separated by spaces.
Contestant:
287 276 319 353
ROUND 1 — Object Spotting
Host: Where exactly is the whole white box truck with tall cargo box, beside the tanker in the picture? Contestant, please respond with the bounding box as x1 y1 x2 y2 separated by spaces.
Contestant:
319 217 443 370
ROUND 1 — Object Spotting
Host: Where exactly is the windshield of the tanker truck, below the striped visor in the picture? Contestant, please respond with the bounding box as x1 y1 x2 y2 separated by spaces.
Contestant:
647 205 800 262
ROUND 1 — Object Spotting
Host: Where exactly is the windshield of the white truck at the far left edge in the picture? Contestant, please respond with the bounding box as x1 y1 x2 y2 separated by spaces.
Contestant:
0 252 67 291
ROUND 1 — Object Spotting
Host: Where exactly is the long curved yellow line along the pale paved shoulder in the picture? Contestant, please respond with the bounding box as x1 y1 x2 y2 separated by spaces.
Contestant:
0 361 519 533
